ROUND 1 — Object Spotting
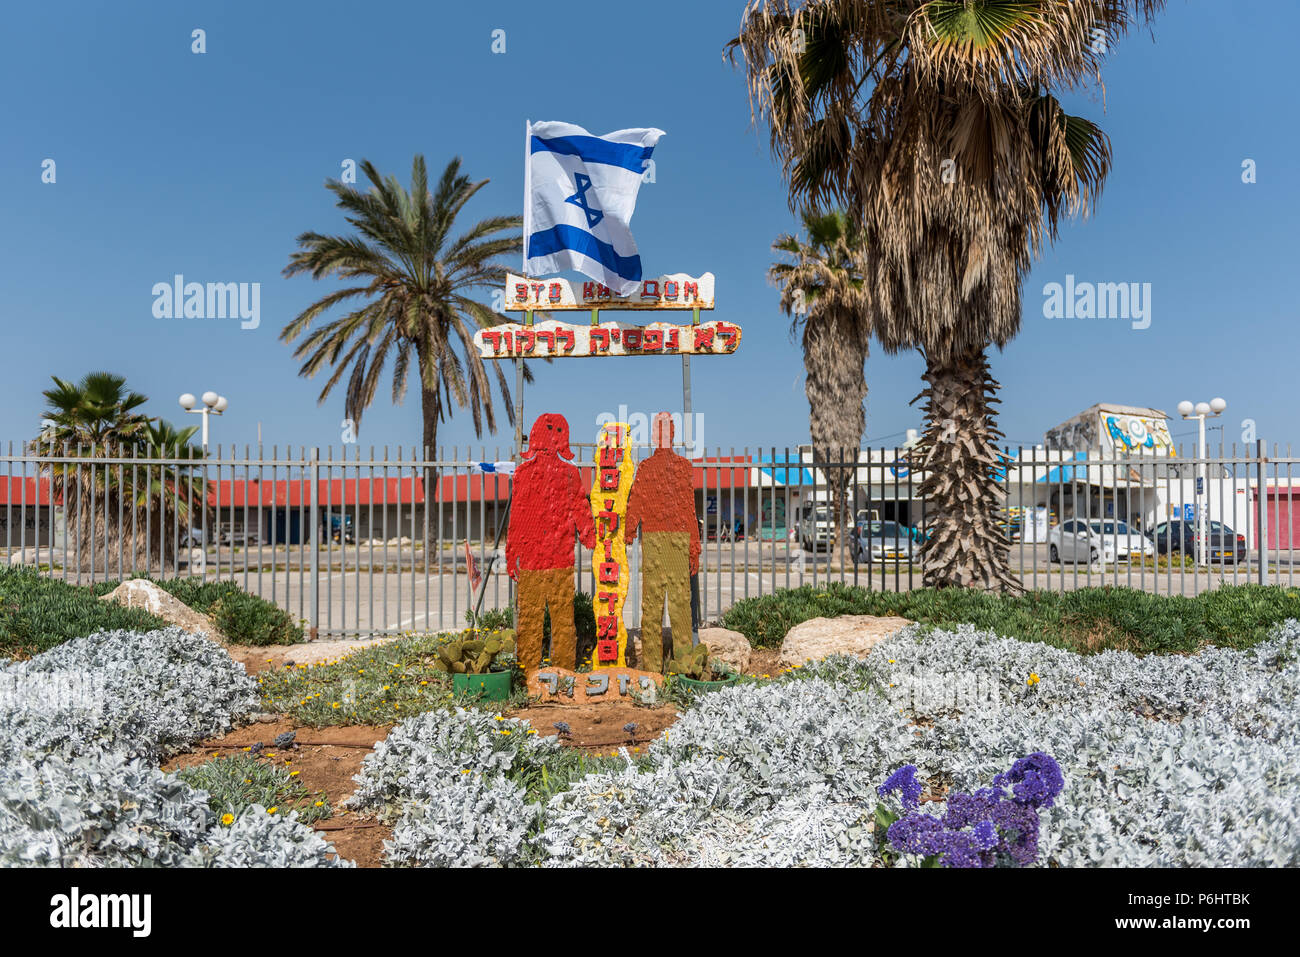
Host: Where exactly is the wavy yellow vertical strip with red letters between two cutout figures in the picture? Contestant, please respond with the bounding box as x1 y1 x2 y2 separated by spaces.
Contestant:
590 423 636 668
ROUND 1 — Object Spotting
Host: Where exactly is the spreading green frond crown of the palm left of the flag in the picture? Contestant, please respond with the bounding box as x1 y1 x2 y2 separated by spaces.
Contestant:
280 155 532 455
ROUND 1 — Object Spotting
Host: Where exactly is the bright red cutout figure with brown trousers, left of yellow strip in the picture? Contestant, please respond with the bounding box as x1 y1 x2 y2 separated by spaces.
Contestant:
506 412 595 671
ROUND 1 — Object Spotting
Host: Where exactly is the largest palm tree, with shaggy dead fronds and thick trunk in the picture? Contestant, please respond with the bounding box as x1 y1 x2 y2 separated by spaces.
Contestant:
731 0 1164 588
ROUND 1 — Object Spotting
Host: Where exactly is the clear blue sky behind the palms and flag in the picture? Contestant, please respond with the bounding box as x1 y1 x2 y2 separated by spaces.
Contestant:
0 0 1300 455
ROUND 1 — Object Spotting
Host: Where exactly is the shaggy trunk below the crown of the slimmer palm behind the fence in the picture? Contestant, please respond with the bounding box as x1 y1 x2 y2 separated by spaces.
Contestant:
803 309 867 568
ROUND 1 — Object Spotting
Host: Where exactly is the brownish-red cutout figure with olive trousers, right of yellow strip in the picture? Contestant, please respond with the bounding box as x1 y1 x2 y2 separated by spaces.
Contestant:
624 412 699 672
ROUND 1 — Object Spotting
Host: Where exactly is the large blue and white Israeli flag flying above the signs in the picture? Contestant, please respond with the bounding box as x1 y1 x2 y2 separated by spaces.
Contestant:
524 122 664 295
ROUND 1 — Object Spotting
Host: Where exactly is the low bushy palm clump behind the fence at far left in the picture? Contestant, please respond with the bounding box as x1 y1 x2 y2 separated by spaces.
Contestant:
29 372 203 573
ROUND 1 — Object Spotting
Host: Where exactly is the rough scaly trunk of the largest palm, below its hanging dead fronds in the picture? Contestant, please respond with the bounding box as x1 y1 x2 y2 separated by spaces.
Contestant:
919 348 1023 592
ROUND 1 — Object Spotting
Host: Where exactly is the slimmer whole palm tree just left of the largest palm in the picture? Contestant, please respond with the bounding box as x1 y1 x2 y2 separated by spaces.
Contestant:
767 209 871 567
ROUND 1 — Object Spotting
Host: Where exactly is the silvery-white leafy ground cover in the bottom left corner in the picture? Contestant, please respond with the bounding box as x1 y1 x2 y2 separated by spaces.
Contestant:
0 628 346 867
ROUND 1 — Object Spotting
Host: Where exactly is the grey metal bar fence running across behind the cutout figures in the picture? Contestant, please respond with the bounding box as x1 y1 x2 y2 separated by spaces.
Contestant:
0 445 1300 637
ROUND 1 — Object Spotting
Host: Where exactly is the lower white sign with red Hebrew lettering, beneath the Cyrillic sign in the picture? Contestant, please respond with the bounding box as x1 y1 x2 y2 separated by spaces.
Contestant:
475 319 740 359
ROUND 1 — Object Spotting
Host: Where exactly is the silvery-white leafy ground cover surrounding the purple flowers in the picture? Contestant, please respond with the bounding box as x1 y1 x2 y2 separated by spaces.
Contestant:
354 620 1300 866
